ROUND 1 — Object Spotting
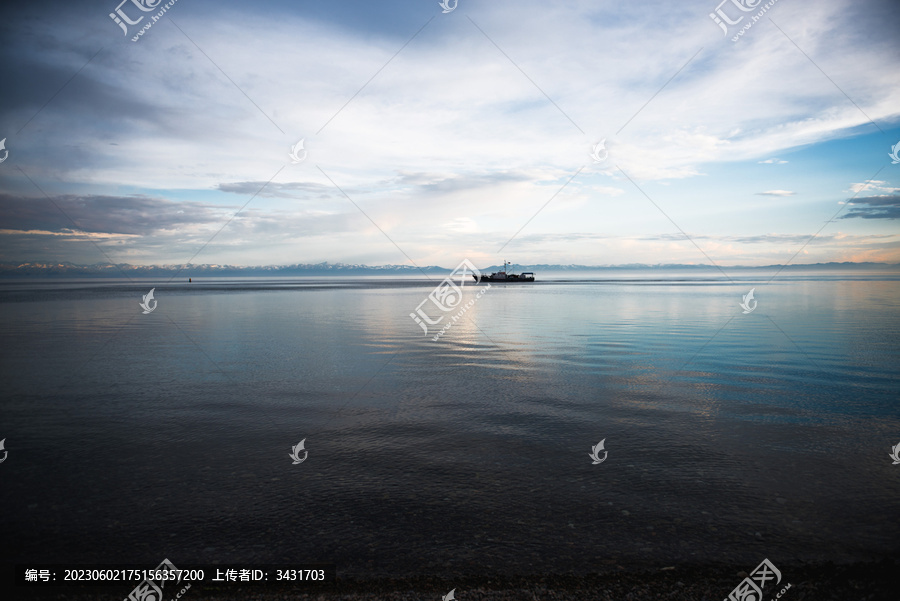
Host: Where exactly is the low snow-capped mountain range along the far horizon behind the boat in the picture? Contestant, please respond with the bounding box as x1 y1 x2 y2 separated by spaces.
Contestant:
0 262 900 278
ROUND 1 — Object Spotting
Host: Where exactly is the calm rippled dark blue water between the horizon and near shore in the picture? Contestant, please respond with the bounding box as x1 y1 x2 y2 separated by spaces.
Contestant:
0 274 900 584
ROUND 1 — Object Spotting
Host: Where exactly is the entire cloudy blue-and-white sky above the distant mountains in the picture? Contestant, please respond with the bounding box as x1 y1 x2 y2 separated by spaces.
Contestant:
0 0 900 267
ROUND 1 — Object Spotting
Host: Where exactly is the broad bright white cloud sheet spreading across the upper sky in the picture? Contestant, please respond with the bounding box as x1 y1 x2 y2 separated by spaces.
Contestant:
8 1 900 189
